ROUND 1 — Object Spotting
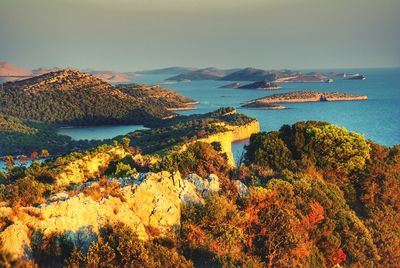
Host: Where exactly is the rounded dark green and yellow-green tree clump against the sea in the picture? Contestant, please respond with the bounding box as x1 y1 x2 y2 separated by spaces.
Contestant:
246 122 370 174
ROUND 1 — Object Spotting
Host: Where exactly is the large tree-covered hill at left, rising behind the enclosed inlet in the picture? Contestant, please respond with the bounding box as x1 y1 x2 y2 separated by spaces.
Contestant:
0 69 197 126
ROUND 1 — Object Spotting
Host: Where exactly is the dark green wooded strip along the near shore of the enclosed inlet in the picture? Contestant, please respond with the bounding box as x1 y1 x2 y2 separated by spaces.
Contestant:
0 107 254 156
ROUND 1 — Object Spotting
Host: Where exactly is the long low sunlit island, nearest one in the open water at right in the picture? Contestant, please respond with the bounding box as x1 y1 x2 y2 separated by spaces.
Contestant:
241 90 368 109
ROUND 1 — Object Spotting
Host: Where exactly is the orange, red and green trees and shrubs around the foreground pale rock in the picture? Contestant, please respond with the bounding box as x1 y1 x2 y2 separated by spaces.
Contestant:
1 121 400 267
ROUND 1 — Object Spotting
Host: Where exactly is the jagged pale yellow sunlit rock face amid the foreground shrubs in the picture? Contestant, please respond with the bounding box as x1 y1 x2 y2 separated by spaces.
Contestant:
0 171 220 258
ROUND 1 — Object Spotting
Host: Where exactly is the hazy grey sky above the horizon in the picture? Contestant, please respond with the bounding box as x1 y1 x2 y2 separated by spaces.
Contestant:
0 0 400 71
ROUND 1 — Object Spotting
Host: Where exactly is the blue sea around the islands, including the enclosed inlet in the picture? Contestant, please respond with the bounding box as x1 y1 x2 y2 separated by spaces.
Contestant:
0 68 400 171
